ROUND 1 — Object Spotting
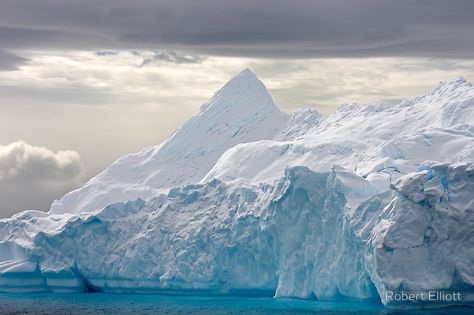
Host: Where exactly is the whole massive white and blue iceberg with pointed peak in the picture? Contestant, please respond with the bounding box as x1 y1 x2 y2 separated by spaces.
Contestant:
0 70 474 308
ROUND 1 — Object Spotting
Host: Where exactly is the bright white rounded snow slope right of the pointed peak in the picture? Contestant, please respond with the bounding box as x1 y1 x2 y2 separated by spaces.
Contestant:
203 78 474 188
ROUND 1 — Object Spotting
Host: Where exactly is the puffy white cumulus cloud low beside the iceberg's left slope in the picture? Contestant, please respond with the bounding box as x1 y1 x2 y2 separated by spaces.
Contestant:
0 141 83 217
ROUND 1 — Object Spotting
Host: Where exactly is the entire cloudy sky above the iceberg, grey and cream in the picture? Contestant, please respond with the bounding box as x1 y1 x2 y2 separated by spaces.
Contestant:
0 0 474 217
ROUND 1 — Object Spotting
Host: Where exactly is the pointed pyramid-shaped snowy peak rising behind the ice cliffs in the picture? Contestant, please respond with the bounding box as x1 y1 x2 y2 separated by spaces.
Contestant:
51 69 288 213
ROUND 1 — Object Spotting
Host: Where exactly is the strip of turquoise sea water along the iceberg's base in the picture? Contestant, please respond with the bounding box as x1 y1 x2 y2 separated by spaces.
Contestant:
0 293 474 315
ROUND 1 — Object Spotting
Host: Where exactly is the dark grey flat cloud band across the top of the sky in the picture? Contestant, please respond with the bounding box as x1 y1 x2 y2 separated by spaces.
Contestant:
0 0 474 65
